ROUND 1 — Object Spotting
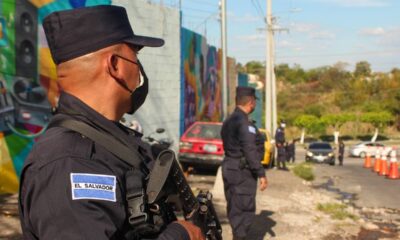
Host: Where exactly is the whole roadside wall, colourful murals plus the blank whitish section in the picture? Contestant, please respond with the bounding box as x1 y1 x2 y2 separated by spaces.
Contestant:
0 0 241 194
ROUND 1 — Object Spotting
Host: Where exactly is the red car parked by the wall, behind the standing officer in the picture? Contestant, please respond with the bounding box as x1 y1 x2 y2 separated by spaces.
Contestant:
178 122 224 171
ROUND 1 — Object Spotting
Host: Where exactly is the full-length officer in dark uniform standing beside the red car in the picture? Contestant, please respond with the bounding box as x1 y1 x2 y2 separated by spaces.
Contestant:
221 87 267 240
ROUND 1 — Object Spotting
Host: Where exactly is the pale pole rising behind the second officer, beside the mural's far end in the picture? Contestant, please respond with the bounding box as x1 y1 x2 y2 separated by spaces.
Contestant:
220 0 228 119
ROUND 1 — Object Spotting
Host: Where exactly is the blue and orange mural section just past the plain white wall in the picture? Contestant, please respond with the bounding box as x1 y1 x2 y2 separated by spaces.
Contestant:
181 28 222 134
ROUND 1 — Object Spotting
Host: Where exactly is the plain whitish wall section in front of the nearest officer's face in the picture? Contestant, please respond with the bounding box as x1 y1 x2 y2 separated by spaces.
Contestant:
112 0 181 150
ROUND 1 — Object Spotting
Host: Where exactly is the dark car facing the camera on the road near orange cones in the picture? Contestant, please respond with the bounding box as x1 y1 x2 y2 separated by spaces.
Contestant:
306 142 335 165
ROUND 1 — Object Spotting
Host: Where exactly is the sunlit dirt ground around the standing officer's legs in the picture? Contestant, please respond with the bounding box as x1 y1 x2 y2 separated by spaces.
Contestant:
213 167 400 240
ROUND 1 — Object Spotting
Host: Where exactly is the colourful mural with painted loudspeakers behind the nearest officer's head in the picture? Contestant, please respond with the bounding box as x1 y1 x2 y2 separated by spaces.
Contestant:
0 0 111 193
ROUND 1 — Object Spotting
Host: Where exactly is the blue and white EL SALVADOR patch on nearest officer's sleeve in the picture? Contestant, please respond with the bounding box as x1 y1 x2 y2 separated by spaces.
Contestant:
71 173 117 202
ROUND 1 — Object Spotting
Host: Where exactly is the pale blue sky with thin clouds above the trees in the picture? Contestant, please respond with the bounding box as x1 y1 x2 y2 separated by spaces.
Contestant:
164 0 400 72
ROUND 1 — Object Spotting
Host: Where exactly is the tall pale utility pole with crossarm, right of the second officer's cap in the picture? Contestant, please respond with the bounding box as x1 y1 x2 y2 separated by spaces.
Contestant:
265 0 273 135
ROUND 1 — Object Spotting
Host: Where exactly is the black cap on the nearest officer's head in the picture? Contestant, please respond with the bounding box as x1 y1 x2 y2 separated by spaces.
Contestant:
43 5 164 64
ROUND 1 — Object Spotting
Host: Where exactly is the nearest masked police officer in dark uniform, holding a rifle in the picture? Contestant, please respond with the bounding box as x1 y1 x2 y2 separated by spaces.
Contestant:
19 6 204 240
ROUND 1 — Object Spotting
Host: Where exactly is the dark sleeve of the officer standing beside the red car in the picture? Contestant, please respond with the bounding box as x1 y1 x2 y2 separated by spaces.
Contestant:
238 122 265 177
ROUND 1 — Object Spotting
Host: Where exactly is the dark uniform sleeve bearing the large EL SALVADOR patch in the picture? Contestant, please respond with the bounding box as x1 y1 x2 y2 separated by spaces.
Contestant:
21 158 126 240
